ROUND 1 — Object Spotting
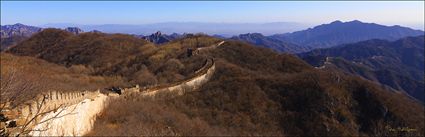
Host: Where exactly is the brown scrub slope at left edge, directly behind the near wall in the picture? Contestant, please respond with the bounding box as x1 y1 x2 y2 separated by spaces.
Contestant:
0 53 122 102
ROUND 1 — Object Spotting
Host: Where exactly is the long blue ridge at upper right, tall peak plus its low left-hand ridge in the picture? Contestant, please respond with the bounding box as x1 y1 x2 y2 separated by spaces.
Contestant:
231 20 424 53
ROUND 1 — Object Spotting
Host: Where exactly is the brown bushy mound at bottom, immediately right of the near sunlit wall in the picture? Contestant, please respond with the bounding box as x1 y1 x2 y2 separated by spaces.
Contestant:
87 96 227 136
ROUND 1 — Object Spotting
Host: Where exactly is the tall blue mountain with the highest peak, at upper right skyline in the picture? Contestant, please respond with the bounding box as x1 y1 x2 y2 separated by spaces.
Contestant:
271 20 424 48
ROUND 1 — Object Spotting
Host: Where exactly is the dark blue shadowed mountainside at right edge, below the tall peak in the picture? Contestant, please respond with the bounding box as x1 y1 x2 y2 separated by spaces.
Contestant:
299 35 425 102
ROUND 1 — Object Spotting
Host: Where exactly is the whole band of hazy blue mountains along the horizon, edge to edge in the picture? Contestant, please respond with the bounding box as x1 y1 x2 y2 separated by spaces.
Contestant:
1 20 424 53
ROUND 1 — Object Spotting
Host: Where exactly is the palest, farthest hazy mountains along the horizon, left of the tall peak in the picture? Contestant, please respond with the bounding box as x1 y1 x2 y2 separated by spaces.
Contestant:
42 22 308 37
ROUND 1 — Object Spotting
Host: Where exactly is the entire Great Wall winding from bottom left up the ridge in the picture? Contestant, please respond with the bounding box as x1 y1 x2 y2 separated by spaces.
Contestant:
0 41 224 136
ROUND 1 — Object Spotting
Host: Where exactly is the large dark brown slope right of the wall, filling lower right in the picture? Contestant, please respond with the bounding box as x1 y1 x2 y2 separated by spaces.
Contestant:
88 41 425 136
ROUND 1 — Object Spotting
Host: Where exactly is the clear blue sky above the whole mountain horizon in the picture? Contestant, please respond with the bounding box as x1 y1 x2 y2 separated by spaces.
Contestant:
1 1 424 29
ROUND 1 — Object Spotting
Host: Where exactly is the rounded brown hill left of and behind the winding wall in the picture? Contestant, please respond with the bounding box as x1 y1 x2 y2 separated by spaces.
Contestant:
7 29 219 87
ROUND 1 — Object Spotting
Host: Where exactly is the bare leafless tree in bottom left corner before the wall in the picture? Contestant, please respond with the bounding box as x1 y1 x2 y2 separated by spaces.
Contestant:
0 67 75 136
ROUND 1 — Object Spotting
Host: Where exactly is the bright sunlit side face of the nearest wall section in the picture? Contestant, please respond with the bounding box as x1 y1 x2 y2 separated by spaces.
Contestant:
29 94 111 136
